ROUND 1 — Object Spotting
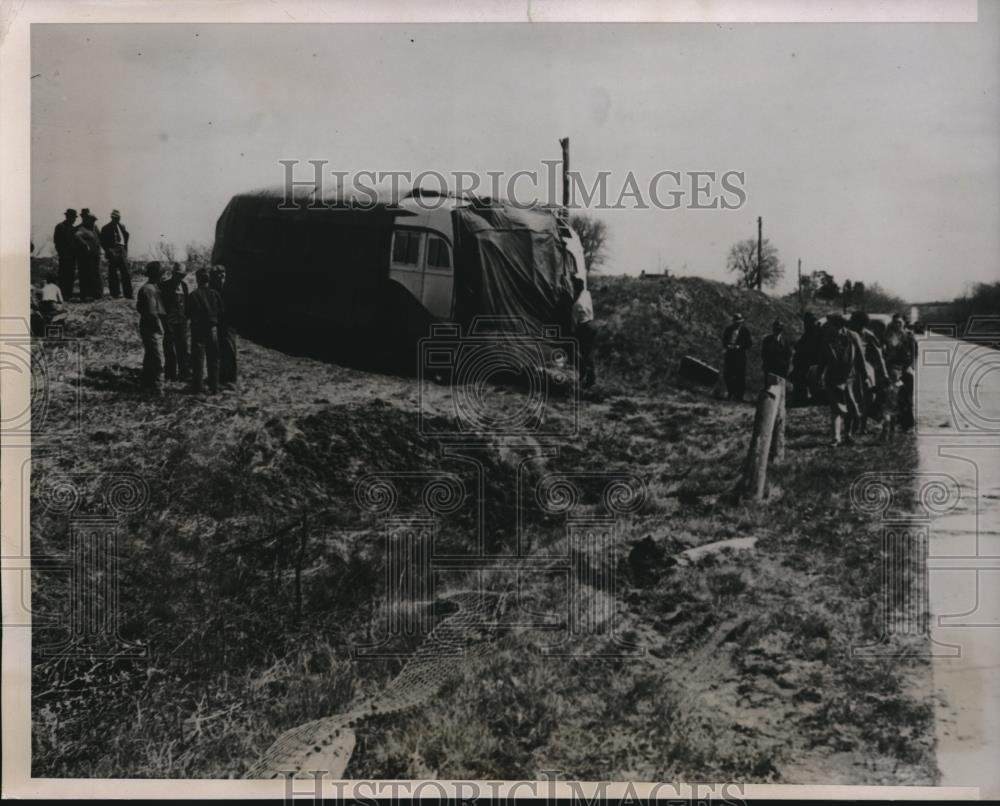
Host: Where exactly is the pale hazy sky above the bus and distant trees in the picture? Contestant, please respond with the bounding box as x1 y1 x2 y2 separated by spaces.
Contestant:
31 17 1000 302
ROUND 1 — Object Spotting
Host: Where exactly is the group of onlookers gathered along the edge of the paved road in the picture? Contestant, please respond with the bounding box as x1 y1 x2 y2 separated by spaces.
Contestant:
722 311 917 446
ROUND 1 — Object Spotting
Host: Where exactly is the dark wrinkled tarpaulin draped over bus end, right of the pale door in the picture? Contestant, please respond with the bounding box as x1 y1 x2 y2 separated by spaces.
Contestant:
453 202 573 332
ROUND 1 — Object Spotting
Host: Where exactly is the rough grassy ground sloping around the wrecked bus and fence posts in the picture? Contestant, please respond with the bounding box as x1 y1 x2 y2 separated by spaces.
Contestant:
31 278 936 784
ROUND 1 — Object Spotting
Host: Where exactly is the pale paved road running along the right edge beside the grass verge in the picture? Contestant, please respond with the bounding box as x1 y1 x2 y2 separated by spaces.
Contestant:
916 335 1000 798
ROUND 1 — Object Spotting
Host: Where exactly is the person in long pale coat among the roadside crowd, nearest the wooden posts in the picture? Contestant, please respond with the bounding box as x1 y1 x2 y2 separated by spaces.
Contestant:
823 313 865 447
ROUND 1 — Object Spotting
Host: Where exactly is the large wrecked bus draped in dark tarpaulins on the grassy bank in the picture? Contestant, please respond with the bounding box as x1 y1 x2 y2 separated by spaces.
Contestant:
212 190 586 366
